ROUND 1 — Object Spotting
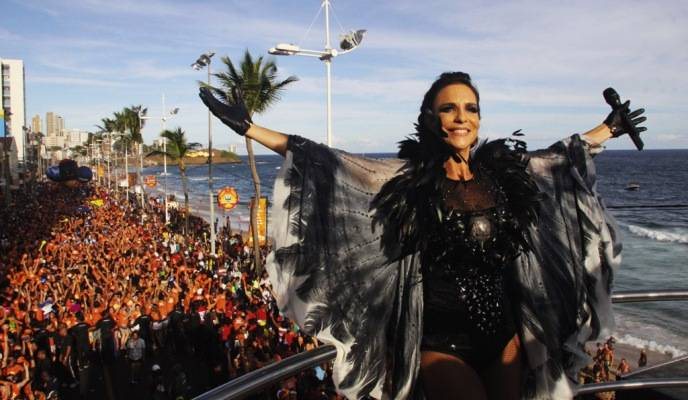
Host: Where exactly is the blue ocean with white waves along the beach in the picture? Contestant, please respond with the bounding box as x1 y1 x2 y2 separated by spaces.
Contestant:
144 150 688 357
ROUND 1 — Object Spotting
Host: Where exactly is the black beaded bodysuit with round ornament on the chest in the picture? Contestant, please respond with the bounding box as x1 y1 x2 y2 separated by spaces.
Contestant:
421 170 519 367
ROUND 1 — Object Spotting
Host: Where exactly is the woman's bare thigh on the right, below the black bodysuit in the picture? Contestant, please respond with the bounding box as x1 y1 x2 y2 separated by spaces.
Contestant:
481 335 521 400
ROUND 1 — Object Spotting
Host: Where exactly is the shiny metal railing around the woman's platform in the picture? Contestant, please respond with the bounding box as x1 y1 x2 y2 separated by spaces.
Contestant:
194 289 688 400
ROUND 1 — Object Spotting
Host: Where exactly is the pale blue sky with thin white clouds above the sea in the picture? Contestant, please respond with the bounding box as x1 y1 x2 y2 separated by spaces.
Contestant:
0 0 688 153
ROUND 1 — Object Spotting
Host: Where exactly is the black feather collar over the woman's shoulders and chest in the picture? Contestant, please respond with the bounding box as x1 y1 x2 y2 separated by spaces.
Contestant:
371 133 540 260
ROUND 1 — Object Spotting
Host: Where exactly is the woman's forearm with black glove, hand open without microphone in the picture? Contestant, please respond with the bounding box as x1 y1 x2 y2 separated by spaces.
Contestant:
198 87 289 156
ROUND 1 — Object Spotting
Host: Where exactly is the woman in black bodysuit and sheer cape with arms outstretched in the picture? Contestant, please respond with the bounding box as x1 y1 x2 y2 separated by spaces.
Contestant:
201 72 644 399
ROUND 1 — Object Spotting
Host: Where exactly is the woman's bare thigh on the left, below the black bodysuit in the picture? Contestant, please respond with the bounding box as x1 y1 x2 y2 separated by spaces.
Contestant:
420 351 487 400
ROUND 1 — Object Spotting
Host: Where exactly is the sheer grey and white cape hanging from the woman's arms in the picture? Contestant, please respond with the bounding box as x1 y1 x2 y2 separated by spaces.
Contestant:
267 135 621 399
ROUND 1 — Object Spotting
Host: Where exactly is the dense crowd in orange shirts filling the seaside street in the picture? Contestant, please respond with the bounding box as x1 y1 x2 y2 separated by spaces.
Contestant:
0 183 338 400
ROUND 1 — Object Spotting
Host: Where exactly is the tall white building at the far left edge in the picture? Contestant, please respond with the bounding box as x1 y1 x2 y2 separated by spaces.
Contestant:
0 58 26 162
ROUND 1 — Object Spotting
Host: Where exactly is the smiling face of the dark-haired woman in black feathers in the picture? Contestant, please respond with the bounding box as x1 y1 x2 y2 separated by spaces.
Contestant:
433 83 480 156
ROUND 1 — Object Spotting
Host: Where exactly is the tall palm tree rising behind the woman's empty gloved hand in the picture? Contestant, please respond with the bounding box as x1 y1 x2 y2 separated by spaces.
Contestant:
207 50 298 273
